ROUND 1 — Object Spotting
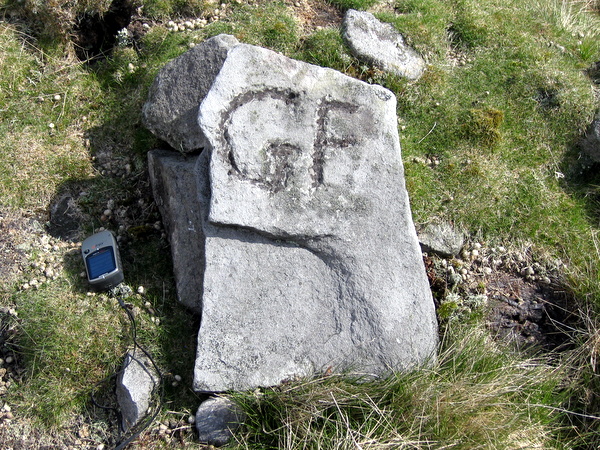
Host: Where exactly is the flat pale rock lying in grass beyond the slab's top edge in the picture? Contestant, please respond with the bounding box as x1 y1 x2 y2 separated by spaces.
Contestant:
343 9 425 80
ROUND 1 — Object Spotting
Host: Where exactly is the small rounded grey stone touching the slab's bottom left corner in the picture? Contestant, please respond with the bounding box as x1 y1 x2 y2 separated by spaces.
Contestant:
196 397 245 447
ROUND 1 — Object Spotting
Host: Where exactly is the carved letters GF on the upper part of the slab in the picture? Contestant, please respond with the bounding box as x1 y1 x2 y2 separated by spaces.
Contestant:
220 88 359 193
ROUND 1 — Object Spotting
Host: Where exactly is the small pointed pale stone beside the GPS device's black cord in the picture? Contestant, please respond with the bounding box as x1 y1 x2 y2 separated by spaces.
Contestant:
116 351 159 431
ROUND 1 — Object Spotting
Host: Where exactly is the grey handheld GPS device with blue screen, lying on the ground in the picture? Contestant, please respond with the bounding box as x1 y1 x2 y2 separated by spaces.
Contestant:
81 230 124 290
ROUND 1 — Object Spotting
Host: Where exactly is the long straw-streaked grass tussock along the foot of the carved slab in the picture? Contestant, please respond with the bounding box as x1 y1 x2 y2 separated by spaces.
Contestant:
232 329 568 449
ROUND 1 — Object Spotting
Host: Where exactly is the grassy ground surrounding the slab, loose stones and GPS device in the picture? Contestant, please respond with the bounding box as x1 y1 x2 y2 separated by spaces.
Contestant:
0 0 600 449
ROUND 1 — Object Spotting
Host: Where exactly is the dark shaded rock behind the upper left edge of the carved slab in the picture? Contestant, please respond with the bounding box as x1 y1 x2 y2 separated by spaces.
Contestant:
142 34 238 153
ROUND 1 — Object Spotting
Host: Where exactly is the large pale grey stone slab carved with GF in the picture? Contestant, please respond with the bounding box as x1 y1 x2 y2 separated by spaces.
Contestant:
194 44 437 391
